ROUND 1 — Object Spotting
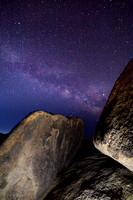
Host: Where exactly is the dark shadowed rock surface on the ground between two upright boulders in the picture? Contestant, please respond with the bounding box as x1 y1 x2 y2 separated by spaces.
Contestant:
44 142 133 200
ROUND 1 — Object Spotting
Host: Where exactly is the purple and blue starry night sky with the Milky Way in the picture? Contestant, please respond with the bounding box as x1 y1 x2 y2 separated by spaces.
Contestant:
0 0 133 137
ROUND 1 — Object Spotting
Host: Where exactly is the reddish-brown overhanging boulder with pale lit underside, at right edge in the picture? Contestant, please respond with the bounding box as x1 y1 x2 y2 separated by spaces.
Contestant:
93 59 133 171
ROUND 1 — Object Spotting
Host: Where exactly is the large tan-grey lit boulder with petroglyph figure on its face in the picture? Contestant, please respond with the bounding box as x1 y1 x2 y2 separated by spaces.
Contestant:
0 111 83 200
